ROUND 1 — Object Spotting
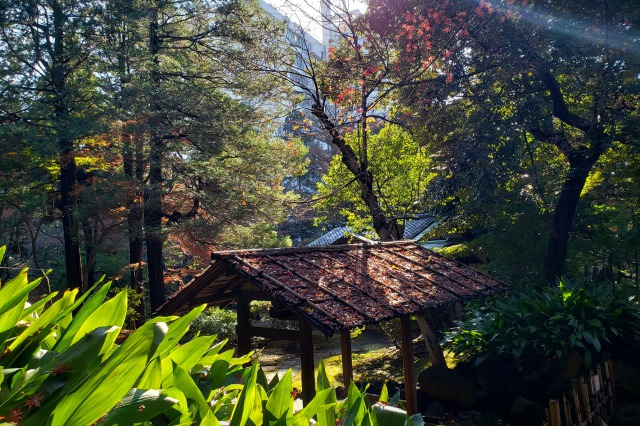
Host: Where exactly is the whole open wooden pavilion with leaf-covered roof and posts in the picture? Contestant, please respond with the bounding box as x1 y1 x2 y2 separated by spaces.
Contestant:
157 241 507 414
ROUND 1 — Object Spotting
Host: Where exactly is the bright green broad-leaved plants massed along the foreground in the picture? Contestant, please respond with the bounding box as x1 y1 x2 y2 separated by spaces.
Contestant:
0 248 422 426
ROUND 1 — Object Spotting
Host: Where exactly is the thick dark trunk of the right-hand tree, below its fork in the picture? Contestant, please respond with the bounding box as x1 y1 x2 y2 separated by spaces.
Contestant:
544 155 599 282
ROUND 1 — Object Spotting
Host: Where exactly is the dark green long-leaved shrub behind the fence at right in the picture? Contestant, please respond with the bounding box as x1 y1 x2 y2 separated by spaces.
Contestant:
445 282 640 363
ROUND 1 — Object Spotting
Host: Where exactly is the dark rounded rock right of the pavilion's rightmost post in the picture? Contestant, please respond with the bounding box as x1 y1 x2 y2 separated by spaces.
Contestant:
418 367 477 407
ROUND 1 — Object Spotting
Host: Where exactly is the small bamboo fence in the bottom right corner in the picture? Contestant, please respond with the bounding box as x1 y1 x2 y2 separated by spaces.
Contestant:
544 354 616 426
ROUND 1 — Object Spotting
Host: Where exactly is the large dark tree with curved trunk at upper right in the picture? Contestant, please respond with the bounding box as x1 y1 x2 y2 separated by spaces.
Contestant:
390 1 639 280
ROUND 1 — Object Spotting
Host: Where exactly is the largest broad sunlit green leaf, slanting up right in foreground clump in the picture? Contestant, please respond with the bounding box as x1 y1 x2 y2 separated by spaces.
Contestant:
51 322 164 426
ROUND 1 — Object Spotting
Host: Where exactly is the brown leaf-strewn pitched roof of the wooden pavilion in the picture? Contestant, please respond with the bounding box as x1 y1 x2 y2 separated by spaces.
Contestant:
158 241 507 335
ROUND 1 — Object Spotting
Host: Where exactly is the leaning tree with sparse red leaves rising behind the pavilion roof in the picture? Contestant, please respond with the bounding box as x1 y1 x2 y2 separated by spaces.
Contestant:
280 1 496 240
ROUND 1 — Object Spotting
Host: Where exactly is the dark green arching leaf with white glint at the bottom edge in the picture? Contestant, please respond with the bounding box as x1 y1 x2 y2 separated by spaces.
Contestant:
103 388 179 425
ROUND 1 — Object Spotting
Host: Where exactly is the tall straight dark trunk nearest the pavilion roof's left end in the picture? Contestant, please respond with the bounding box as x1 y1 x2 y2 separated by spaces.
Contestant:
144 10 165 311
